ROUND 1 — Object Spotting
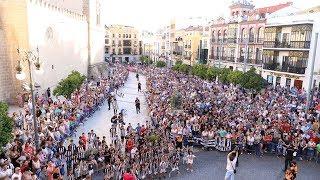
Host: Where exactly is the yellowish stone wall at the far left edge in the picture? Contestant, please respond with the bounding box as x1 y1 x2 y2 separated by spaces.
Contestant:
0 0 28 103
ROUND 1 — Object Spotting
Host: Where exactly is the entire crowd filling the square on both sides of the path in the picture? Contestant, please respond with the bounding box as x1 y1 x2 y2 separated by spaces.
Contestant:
0 62 320 180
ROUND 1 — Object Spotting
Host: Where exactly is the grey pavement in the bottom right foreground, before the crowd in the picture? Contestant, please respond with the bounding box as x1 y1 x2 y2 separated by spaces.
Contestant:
171 151 320 180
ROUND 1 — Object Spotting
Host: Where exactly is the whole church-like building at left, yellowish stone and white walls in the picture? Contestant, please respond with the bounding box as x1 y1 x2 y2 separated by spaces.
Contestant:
0 0 104 103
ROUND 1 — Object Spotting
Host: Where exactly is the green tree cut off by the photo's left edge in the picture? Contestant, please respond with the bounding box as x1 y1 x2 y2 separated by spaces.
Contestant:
0 102 13 152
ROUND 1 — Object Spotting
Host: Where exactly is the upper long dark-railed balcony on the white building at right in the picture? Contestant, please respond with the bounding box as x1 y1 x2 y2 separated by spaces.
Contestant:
263 40 310 49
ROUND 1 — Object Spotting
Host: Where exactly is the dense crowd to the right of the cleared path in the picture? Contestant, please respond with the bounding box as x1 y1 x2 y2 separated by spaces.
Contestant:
146 68 320 179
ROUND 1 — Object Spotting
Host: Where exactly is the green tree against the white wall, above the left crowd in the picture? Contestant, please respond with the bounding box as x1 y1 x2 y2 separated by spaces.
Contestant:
53 71 86 98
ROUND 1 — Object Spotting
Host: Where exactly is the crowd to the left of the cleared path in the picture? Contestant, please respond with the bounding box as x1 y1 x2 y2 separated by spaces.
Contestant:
0 65 128 180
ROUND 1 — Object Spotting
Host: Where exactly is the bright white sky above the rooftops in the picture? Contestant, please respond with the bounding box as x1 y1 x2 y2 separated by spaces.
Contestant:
104 0 320 31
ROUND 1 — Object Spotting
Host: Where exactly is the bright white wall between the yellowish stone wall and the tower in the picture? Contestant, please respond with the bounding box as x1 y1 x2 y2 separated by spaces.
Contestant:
27 2 88 90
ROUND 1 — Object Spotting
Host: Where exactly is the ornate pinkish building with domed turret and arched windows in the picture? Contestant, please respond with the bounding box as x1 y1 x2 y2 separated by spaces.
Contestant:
209 0 292 72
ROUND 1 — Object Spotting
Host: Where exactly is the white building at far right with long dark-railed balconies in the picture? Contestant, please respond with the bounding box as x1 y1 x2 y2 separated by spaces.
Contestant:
262 11 320 92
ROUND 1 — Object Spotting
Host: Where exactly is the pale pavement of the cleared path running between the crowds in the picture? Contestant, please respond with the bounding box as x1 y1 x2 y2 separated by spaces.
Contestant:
73 72 150 143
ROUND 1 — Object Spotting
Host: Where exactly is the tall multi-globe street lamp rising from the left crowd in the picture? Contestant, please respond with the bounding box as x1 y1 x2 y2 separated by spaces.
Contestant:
16 48 43 150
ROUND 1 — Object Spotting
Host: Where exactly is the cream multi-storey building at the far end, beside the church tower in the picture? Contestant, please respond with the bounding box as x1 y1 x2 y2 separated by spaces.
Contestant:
105 25 141 62
